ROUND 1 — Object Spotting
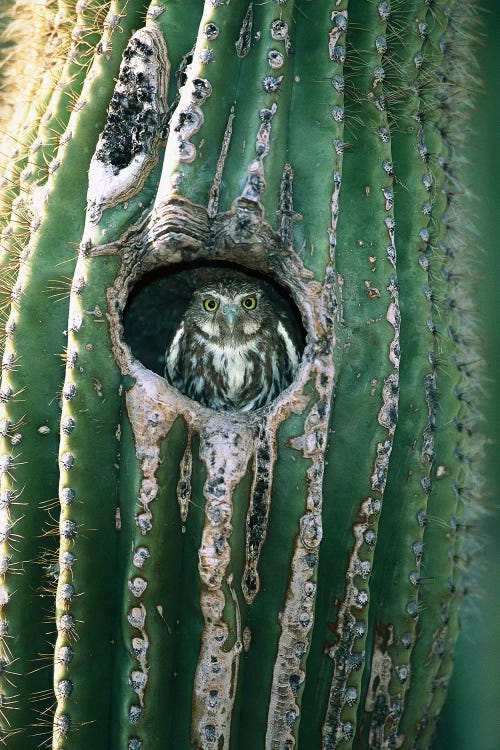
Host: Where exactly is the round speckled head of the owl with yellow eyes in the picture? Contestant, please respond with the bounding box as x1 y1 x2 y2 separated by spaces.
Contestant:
185 275 273 344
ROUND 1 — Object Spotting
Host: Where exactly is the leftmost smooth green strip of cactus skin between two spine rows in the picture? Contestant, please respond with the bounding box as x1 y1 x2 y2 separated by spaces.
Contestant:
1 4 154 747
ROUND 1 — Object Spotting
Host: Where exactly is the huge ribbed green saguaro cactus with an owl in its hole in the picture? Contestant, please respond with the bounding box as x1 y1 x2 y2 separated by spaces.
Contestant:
0 0 484 750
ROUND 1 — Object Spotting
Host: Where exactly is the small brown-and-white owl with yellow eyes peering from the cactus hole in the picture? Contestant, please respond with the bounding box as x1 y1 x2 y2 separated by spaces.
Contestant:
165 272 299 411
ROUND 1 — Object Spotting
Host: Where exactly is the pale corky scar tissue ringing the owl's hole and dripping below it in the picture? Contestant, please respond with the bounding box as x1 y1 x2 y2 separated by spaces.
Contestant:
100 176 334 747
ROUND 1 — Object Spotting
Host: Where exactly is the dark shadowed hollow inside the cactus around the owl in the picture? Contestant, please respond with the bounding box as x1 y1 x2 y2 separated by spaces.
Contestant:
123 262 306 411
